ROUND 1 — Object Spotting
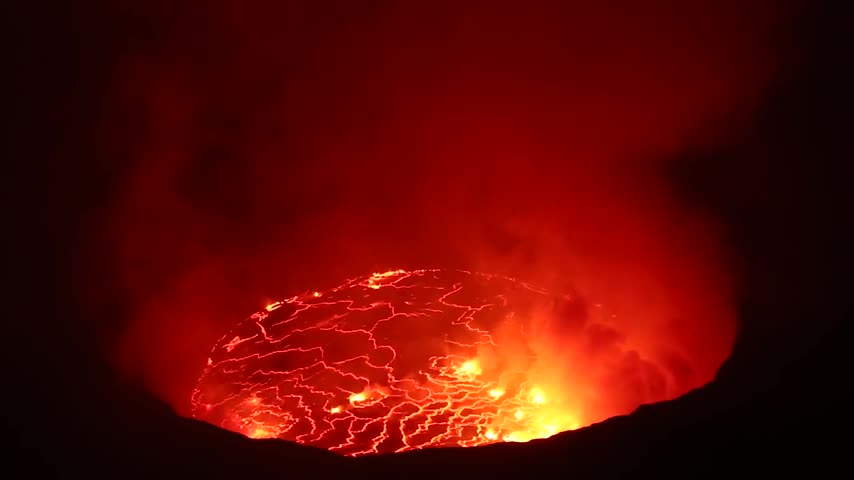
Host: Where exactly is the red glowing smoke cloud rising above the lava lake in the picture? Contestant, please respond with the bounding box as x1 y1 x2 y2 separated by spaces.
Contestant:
86 1 796 413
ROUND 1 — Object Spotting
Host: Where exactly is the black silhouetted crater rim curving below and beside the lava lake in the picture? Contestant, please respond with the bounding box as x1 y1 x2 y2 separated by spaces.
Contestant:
4 0 854 479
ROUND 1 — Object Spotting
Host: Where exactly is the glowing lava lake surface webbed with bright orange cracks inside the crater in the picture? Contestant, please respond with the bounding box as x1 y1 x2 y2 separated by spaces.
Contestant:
192 270 589 456
